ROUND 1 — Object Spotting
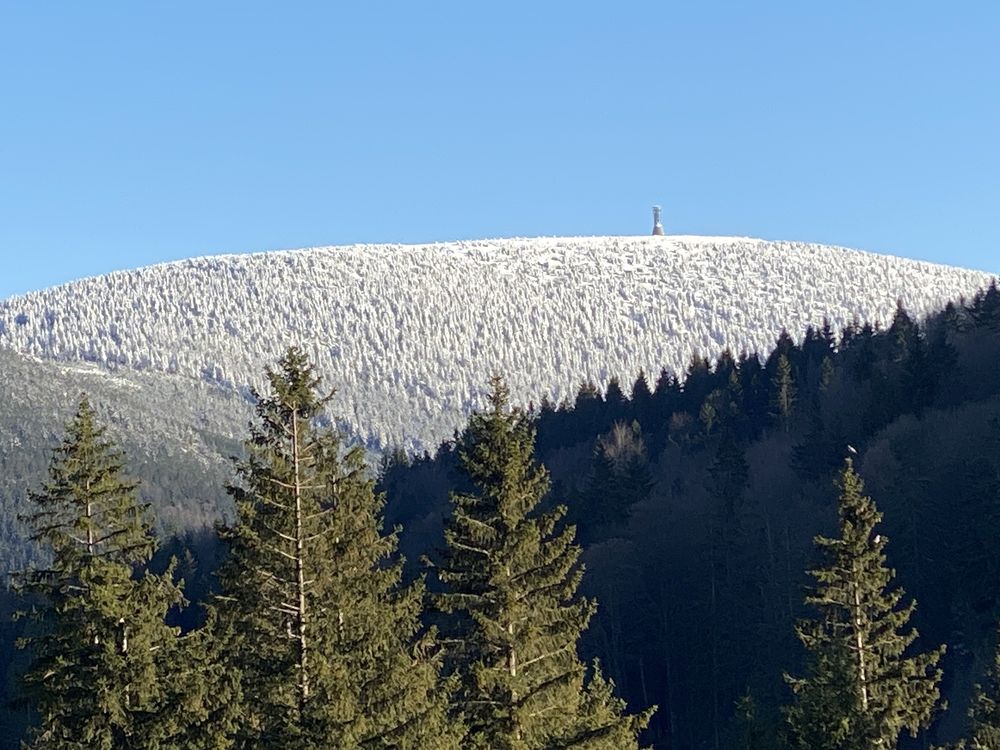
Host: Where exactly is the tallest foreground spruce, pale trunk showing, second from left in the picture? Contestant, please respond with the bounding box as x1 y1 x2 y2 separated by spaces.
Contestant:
214 349 458 750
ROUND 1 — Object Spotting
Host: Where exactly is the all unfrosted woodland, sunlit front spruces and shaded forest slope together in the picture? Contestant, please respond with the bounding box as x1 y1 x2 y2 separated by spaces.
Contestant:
5 285 1000 750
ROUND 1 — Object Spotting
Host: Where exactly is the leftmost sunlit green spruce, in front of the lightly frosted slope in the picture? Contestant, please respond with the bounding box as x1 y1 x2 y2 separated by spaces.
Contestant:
15 399 183 750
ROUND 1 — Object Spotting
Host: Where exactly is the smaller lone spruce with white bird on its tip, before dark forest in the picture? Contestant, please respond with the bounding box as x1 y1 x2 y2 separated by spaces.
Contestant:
787 459 944 750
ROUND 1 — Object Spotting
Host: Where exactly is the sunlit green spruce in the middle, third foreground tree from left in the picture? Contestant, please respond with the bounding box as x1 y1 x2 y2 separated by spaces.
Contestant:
437 378 651 750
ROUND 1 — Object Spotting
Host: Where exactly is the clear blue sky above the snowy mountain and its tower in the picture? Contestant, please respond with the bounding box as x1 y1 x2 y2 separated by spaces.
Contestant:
0 0 1000 297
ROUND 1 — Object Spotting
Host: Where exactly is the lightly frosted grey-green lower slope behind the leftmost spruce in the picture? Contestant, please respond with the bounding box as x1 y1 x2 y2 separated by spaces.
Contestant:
0 350 251 580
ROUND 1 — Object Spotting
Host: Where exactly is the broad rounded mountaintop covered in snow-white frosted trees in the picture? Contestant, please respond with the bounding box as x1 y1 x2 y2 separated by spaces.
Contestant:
0 237 989 448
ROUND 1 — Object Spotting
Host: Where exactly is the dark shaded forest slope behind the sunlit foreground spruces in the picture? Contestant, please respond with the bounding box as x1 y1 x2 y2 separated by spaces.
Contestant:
381 286 1000 749
